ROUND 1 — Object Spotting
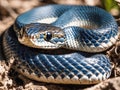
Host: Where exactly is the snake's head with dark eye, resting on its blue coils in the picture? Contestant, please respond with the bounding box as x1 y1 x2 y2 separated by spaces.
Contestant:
18 23 65 49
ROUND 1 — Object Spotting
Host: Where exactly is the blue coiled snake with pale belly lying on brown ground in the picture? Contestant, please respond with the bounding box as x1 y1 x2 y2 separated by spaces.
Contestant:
3 4 118 84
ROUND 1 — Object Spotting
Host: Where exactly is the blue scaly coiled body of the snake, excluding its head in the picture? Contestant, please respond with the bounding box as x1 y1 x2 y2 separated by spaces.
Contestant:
3 5 118 84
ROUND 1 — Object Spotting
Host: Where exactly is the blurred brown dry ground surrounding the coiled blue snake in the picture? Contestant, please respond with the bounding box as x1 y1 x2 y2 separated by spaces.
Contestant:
0 0 120 90
